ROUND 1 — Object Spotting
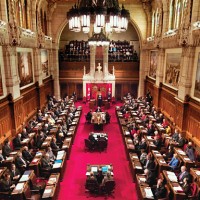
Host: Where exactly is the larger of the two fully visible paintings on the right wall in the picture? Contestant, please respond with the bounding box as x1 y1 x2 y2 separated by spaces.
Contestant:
165 53 181 88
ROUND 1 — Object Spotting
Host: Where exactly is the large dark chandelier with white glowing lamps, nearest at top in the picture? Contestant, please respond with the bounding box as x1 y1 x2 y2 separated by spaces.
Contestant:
67 0 130 34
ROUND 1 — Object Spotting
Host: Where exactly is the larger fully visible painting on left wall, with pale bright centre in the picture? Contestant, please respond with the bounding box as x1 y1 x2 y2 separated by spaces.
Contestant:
17 52 33 87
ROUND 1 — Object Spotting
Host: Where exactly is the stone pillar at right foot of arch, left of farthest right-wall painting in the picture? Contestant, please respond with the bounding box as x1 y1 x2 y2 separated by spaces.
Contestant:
138 50 149 96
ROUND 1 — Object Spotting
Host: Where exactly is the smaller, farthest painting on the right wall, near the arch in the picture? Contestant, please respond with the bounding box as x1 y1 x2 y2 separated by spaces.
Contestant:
149 51 158 79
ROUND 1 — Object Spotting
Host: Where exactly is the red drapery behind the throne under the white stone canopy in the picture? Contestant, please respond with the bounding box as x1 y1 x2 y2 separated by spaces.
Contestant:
86 83 112 101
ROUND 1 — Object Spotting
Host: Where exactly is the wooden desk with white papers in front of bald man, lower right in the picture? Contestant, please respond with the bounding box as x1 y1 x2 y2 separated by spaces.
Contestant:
163 170 186 200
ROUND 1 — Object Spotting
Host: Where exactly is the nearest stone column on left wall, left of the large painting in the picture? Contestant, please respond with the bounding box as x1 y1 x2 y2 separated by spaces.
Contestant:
2 46 20 100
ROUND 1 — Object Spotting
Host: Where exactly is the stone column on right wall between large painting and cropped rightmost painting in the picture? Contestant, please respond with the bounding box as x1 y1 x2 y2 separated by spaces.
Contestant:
178 47 195 101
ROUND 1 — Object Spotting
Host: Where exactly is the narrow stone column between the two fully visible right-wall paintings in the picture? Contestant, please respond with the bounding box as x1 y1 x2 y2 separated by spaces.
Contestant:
156 49 165 87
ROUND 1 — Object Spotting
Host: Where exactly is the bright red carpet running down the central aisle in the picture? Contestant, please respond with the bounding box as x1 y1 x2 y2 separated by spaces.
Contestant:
58 104 137 200
